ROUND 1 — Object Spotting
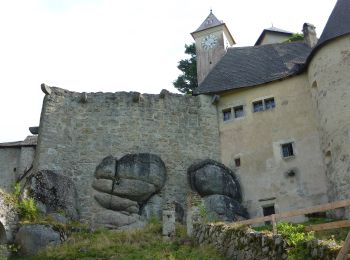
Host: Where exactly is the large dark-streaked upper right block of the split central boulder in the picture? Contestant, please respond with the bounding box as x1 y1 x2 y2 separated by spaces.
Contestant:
117 153 166 190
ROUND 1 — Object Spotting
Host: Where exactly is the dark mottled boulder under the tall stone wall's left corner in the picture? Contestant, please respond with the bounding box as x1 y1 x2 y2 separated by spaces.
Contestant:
32 170 79 219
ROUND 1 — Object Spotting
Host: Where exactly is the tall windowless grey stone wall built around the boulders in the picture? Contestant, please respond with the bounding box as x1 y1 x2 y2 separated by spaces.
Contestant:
34 88 220 223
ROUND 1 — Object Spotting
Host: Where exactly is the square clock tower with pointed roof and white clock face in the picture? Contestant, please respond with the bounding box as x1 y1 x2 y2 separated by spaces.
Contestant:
191 10 235 84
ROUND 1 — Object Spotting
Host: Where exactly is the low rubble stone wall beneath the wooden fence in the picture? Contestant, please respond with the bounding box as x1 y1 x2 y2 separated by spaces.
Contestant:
192 223 341 260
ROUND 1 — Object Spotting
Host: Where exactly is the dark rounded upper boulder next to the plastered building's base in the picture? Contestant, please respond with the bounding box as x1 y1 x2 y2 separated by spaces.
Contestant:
188 160 242 202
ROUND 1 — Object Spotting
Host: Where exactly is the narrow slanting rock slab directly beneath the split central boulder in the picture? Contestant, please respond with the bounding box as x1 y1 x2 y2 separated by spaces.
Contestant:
94 193 139 213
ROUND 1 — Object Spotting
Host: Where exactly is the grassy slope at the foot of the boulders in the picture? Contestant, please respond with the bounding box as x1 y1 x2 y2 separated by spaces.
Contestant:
13 223 223 260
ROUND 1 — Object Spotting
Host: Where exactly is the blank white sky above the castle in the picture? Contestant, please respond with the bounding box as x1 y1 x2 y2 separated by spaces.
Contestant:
0 0 336 142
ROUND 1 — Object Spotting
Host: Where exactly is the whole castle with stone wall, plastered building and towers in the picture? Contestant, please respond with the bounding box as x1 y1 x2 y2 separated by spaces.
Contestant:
0 0 350 244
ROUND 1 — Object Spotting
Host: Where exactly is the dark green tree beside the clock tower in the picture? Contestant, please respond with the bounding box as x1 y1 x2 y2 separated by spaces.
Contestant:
173 43 198 94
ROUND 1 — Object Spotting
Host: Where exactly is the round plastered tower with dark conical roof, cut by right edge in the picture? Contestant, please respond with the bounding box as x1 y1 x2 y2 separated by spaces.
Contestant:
308 0 350 212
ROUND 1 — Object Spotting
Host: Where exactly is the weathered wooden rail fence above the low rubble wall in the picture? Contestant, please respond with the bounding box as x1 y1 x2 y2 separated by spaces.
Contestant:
234 199 350 260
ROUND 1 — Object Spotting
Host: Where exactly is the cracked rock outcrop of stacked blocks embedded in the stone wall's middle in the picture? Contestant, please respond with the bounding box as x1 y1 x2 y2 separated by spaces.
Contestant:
92 153 166 228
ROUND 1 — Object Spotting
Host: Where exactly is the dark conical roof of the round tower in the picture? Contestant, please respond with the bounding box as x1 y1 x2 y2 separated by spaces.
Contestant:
316 0 350 48
